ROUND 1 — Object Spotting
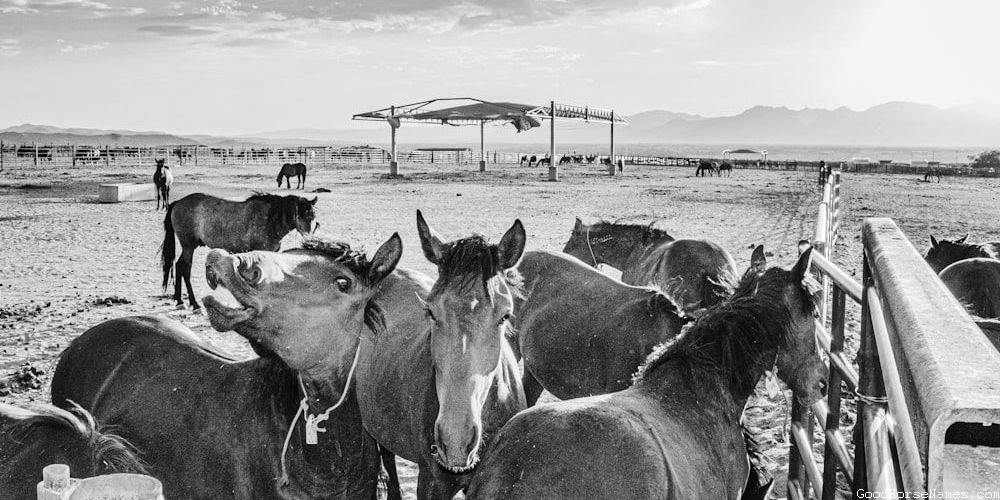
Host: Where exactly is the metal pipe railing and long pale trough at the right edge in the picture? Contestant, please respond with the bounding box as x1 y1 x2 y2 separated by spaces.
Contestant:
787 172 1000 500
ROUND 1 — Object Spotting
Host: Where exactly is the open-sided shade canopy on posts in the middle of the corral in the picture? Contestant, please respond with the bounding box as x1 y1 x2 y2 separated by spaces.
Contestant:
353 97 628 177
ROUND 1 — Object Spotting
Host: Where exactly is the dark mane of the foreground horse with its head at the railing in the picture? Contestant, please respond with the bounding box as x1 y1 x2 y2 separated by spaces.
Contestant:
633 268 819 393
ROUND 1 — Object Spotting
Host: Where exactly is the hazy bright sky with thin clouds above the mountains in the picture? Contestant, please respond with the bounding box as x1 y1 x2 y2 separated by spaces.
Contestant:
0 0 1000 134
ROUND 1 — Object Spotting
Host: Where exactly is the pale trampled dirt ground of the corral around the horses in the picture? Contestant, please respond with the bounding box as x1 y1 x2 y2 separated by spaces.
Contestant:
0 161 1000 498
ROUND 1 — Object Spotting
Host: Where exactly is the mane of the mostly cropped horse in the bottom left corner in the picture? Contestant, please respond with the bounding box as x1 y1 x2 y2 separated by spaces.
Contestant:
0 401 148 475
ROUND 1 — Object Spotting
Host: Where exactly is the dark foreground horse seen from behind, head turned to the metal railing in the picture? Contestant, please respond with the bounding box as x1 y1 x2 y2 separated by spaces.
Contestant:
466 250 826 500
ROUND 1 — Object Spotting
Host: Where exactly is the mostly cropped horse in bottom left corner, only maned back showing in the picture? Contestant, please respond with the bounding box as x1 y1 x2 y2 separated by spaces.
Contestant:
0 403 147 500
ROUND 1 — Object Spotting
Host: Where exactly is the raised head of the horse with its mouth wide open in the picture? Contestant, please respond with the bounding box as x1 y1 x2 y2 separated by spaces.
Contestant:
204 234 403 376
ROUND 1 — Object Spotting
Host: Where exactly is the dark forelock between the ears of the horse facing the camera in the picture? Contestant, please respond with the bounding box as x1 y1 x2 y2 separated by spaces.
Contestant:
432 234 524 296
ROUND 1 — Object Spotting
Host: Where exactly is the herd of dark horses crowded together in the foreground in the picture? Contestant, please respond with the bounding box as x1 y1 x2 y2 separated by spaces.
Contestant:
0 166 1000 499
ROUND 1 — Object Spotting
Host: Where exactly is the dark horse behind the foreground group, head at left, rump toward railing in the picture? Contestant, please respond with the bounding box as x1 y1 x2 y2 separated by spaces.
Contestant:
563 218 736 311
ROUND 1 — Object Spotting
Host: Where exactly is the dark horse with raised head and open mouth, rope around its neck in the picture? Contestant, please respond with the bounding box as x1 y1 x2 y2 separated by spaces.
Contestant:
52 235 402 499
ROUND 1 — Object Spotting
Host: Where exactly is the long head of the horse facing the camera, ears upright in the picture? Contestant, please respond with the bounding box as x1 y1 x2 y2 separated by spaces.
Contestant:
417 211 525 472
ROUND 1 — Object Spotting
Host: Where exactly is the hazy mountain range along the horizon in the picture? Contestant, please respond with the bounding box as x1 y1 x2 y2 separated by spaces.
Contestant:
0 102 1000 147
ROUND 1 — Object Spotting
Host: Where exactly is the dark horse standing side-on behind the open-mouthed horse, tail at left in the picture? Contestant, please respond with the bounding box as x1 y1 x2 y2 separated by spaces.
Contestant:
161 193 319 310
